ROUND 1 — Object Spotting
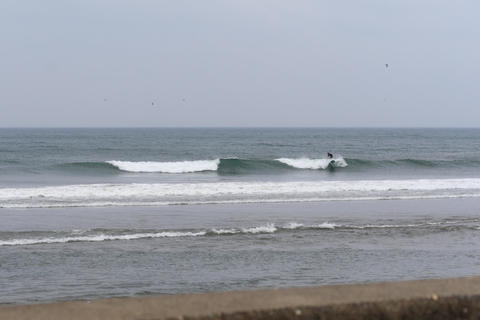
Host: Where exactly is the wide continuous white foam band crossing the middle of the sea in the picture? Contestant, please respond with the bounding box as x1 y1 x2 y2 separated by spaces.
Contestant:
0 178 480 208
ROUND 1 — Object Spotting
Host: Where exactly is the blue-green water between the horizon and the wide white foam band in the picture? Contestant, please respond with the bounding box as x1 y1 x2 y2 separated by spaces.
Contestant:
0 128 480 186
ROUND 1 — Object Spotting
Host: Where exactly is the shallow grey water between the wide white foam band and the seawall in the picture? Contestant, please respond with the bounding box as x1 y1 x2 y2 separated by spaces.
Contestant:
0 198 480 303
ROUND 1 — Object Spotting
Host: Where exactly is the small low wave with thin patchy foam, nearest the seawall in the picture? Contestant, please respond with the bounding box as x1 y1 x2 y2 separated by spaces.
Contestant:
0 219 479 246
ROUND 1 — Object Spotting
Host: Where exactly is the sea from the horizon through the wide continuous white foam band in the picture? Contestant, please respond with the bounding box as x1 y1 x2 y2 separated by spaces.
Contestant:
0 129 480 208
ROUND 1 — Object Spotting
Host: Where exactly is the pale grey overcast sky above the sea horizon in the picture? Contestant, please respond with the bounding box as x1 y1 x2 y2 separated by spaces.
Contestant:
0 0 480 127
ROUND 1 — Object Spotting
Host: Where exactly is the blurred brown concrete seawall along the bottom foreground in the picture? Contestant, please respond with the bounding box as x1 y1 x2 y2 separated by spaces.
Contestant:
0 277 480 320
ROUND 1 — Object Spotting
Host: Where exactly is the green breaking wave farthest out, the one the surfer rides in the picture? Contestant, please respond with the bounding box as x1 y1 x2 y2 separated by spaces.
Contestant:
48 157 480 175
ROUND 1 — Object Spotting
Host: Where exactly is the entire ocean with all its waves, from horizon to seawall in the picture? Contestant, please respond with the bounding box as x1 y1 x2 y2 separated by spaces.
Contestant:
0 128 480 304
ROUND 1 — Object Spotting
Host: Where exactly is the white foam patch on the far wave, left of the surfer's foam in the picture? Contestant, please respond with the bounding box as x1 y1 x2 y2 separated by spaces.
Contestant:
106 159 220 173
